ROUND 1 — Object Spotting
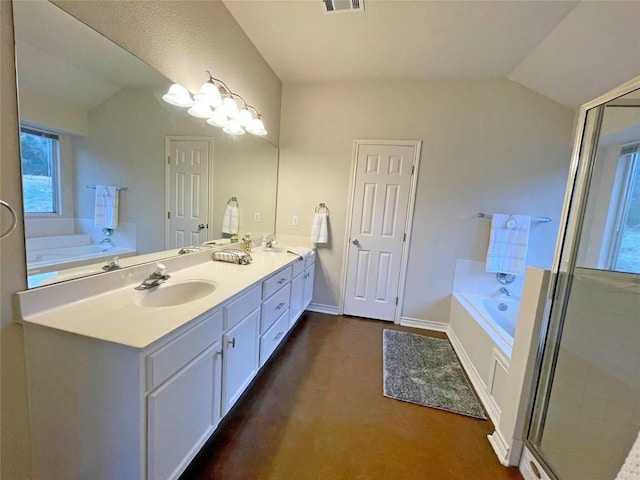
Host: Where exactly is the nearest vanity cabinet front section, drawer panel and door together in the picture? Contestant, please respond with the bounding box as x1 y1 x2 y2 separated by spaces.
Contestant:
145 310 222 480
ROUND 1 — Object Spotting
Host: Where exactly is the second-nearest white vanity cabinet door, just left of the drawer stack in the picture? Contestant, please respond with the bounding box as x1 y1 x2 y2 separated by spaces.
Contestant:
222 309 260 414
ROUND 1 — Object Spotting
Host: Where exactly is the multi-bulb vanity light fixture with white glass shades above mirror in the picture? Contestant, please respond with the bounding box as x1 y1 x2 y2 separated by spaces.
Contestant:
162 71 267 136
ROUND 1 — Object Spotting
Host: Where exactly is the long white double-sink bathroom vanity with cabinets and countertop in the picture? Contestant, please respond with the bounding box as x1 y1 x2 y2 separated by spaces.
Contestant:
17 251 315 480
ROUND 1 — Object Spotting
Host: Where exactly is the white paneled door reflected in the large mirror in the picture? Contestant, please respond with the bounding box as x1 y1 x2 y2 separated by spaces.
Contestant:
166 137 212 249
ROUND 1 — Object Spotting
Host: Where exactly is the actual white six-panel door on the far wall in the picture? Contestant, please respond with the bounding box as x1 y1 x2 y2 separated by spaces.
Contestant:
343 141 420 321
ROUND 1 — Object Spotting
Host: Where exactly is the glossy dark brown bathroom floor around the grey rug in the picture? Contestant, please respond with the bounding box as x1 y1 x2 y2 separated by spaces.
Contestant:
181 313 522 480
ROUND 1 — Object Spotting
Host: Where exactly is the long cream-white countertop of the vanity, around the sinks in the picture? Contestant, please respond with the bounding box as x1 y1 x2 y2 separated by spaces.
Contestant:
18 250 300 349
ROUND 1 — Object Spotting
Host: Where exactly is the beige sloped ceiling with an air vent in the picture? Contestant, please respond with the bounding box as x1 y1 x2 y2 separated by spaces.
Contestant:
224 0 640 108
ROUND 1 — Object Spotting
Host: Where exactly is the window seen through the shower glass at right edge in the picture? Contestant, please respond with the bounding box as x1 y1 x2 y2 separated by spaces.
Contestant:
611 143 640 273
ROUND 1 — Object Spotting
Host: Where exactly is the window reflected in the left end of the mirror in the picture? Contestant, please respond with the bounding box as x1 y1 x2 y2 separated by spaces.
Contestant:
20 127 60 213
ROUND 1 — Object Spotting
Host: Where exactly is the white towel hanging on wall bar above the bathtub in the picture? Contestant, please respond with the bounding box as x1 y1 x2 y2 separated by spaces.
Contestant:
485 213 531 275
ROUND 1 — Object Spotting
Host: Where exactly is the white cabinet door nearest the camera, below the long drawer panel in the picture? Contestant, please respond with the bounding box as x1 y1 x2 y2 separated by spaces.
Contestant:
147 342 221 480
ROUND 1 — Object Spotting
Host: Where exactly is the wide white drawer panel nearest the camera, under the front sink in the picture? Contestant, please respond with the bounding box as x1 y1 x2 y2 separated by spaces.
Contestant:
145 310 222 391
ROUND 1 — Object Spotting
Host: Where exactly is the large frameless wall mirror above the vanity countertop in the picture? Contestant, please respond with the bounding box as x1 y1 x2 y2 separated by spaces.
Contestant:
14 1 278 288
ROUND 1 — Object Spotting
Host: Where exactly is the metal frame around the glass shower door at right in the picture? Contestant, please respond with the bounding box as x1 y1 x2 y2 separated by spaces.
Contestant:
523 76 640 480
